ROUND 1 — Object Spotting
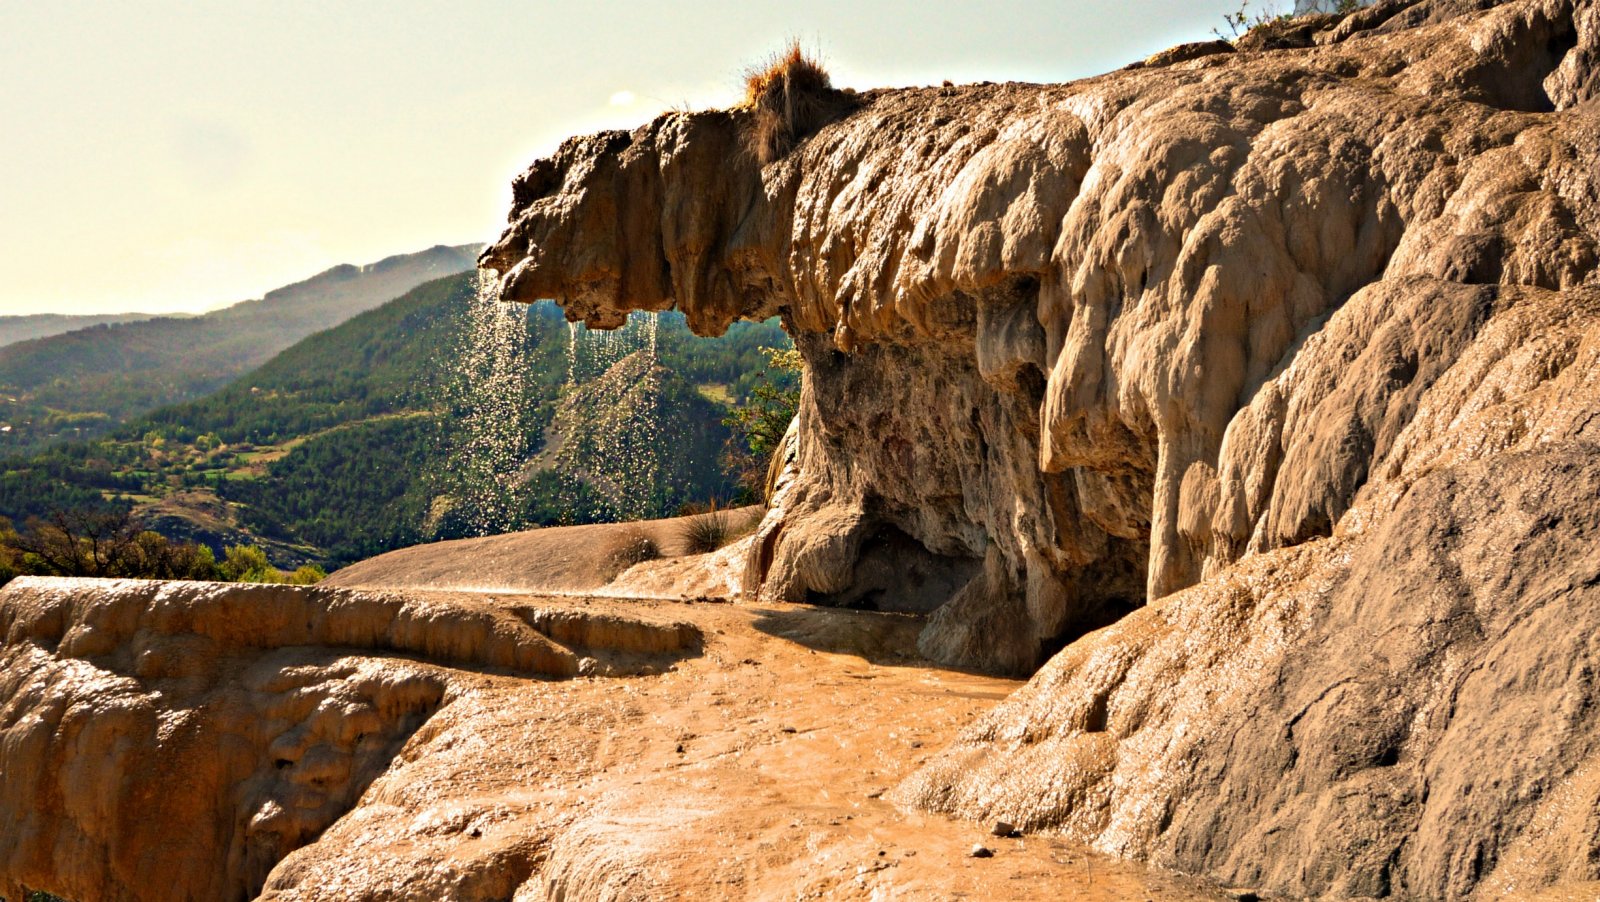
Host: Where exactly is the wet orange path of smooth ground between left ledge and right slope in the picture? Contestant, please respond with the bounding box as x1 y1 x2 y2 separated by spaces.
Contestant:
262 593 1227 900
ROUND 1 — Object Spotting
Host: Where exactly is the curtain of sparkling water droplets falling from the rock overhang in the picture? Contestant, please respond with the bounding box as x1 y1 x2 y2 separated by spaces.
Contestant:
426 272 706 537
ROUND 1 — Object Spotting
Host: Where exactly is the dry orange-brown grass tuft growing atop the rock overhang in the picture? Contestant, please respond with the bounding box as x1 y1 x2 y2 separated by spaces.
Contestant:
744 42 853 166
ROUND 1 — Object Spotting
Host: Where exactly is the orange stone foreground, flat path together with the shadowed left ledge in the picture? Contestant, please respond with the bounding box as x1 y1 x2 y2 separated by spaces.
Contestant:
0 582 1224 902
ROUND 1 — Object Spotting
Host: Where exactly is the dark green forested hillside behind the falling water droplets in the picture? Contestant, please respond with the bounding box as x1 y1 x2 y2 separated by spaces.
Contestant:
0 267 787 566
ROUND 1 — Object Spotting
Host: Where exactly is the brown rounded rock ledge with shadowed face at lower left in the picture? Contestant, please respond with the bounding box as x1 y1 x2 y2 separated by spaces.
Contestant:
0 577 699 900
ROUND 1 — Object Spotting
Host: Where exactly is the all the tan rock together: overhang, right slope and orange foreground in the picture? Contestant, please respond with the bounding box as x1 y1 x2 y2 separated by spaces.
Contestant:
0 0 1600 900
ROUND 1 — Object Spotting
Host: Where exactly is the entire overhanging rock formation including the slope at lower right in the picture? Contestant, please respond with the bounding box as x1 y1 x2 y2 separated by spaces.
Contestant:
483 0 1600 897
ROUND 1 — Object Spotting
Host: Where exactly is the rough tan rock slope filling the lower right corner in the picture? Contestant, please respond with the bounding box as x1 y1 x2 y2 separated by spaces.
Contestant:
898 443 1600 899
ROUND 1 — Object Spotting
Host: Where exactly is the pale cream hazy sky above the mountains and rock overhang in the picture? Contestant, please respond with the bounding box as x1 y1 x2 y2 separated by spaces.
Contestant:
0 0 1238 315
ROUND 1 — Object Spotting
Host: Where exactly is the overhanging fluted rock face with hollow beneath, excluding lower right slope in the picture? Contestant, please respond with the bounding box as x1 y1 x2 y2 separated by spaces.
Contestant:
483 0 1600 672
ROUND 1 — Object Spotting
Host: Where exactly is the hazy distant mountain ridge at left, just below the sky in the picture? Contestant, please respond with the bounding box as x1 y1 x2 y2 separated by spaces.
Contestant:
0 245 477 453
